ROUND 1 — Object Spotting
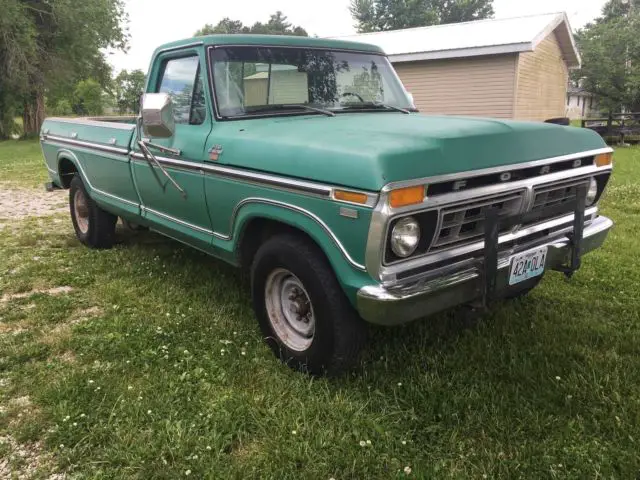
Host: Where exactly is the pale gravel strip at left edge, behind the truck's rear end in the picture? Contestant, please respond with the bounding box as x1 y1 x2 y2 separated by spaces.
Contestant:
0 188 69 222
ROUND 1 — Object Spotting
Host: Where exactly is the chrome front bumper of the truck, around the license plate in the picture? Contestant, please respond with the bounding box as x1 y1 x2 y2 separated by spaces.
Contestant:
357 217 613 325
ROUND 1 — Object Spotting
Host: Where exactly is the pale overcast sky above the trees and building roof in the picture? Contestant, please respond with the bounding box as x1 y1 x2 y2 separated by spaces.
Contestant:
109 0 606 71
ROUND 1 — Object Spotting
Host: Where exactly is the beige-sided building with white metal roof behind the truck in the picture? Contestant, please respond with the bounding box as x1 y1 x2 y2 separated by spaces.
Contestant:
340 13 580 120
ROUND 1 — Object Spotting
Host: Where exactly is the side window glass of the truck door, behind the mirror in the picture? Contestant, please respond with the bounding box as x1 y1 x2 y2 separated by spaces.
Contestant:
158 57 206 125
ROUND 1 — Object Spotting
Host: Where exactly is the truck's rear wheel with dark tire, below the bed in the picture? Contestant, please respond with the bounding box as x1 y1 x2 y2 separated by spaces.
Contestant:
69 174 118 248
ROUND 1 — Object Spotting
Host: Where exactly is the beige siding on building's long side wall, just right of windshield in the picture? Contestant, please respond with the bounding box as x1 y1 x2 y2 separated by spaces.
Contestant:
394 54 518 118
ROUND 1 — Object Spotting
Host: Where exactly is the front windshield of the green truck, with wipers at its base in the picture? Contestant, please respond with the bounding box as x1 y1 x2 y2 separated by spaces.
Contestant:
211 47 414 118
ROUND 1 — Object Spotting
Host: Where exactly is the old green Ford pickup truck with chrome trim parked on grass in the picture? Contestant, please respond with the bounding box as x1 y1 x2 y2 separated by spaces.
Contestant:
41 35 612 374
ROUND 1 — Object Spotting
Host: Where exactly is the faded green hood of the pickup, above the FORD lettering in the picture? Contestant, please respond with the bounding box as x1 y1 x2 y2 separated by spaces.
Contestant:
210 112 606 191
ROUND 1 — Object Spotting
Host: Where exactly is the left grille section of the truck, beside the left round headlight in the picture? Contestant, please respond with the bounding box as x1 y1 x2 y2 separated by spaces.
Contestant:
430 190 524 251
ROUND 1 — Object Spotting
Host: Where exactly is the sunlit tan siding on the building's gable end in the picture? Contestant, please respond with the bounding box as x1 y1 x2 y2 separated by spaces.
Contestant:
515 33 569 120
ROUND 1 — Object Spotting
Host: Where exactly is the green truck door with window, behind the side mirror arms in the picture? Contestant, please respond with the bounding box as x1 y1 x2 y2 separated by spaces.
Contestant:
132 49 212 246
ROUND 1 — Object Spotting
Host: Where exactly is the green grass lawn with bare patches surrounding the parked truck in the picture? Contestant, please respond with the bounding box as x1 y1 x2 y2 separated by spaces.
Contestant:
0 142 640 479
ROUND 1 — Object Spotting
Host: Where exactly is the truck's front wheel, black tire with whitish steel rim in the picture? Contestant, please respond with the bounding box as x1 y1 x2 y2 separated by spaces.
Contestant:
251 234 367 375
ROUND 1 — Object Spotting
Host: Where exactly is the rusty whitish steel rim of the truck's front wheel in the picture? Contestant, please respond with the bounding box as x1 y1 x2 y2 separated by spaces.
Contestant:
264 268 316 352
